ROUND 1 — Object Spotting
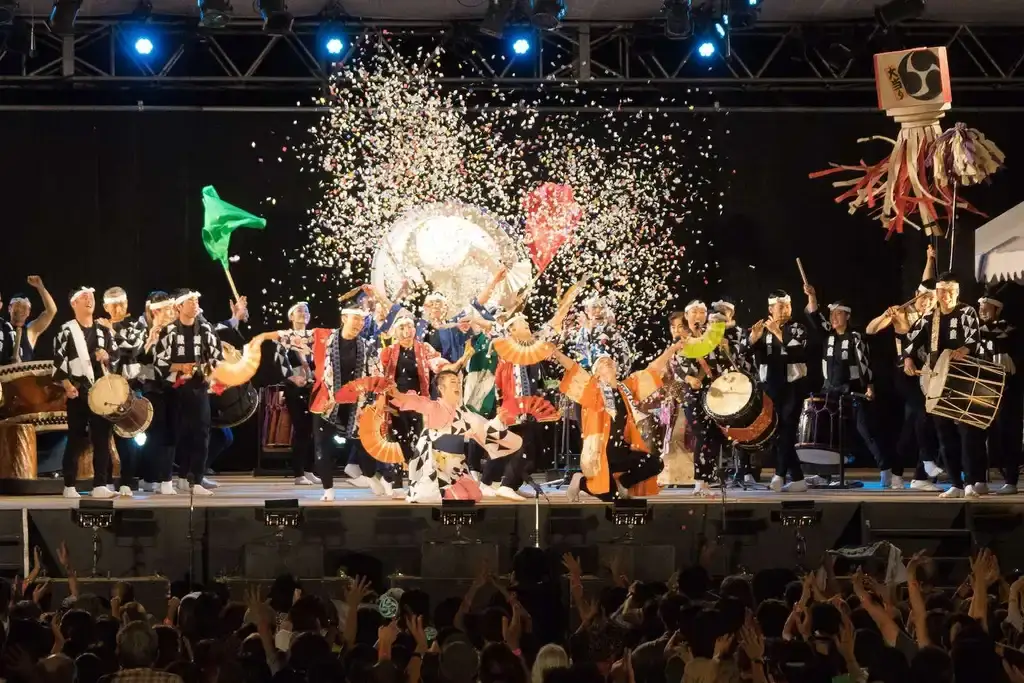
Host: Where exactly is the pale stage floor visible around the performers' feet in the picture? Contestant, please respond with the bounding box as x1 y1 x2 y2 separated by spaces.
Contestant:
0 470 1024 510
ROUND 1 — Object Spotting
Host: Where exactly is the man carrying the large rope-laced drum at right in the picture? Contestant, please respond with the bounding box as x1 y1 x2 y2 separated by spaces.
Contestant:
903 272 988 498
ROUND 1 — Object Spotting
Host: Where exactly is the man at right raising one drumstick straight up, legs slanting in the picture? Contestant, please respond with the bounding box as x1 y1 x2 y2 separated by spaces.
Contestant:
804 285 903 490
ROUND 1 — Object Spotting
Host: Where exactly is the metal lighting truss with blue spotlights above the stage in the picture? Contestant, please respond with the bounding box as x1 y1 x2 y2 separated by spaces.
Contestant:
0 18 1024 108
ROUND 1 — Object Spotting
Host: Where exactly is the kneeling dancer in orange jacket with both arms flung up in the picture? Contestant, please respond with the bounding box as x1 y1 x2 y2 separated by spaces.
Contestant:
552 341 682 502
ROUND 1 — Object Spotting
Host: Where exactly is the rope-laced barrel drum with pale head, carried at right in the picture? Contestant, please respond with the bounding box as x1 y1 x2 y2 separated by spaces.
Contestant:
921 350 1007 429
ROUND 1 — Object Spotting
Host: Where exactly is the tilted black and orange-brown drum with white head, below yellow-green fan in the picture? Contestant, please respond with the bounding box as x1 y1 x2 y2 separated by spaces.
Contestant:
701 370 778 451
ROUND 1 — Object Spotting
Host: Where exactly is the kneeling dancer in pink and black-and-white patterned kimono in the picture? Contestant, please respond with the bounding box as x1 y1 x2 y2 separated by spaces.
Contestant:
391 370 523 503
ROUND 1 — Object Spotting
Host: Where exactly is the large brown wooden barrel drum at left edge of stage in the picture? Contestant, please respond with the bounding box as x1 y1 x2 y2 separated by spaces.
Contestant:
0 360 68 432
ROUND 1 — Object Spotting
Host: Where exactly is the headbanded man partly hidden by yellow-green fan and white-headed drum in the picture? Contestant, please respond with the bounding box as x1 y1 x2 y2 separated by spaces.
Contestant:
672 299 729 497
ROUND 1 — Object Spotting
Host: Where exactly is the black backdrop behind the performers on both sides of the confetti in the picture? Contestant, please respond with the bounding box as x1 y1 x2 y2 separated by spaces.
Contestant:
0 111 1024 473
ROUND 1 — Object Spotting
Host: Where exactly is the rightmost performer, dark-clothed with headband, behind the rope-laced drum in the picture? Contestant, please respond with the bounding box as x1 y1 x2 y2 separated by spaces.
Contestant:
978 291 1024 496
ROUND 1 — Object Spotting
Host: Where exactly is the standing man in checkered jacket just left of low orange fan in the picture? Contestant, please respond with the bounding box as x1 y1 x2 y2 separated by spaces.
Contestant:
155 291 224 496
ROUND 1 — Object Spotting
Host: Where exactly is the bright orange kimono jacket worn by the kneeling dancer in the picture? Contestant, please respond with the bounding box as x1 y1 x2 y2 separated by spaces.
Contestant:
559 364 662 496
